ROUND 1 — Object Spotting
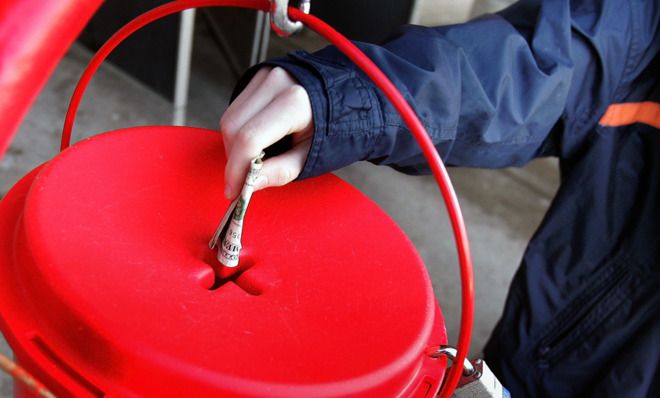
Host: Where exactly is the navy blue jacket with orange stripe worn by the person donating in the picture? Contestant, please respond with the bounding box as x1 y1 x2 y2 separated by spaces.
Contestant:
256 0 660 397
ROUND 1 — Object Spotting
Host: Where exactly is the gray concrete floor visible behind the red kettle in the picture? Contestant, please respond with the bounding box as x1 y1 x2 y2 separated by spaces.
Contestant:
0 3 558 397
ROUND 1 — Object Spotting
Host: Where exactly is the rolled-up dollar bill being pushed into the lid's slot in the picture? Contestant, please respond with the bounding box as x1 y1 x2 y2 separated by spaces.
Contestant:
209 152 264 267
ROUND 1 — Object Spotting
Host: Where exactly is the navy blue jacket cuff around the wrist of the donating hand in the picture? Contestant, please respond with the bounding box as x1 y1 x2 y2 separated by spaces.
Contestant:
266 51 382 179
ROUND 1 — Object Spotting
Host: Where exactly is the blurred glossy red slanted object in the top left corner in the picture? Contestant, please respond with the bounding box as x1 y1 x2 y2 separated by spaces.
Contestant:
0 0 102 159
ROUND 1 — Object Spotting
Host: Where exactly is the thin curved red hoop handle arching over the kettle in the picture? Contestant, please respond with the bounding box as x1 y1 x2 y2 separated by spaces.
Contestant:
60 0 474 398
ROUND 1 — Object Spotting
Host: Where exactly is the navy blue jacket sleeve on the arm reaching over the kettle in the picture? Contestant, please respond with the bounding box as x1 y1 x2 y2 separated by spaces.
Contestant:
269 0 658 178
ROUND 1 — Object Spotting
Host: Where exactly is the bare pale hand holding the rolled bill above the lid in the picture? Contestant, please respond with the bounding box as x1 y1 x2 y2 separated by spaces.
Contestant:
220 67 314 199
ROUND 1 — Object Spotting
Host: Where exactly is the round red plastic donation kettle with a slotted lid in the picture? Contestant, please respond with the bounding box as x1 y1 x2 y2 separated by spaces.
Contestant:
0 0 469 397
